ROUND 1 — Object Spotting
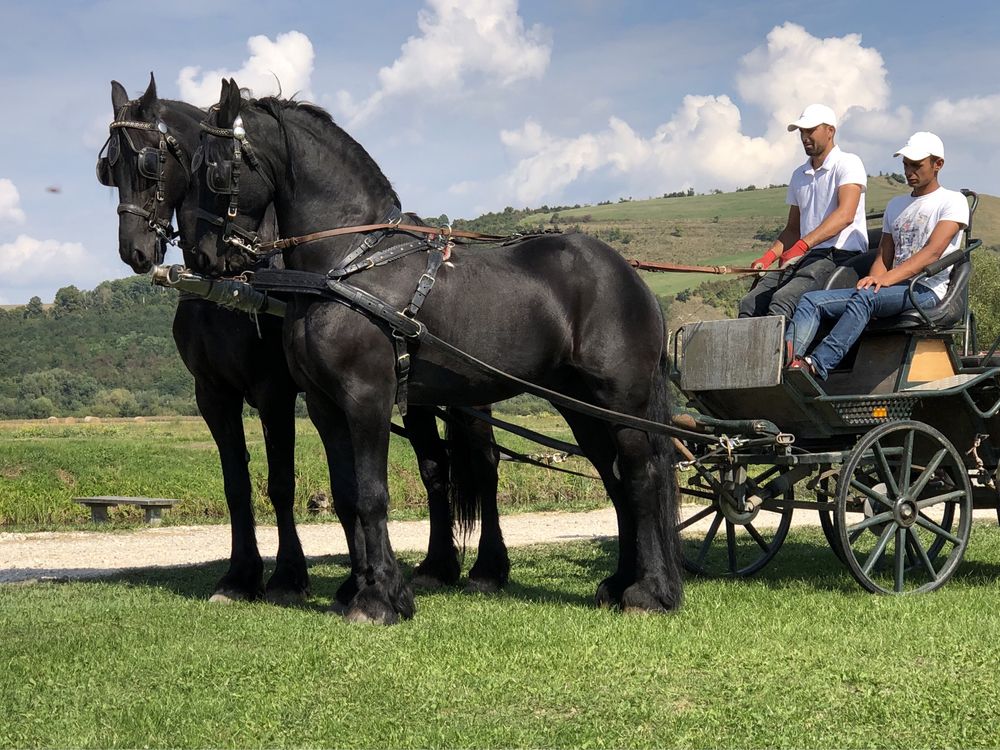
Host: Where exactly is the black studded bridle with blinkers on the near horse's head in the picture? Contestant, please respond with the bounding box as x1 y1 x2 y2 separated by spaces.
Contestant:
191 114 274 260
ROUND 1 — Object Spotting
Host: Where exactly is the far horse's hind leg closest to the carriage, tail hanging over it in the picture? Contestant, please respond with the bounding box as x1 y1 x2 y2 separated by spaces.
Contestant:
448 406 510 593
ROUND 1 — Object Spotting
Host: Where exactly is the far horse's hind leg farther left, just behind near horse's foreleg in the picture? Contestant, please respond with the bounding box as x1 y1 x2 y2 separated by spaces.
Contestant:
403 406 462 589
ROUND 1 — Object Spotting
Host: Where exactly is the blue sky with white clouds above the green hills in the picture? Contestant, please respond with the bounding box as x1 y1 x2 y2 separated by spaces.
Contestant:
0 0 1000 304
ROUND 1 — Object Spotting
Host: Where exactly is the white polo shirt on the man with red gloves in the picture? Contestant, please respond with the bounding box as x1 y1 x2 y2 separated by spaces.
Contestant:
785 146 868 252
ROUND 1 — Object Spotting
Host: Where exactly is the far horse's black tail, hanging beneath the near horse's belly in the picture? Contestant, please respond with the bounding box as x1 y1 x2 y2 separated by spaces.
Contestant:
445 407 499 538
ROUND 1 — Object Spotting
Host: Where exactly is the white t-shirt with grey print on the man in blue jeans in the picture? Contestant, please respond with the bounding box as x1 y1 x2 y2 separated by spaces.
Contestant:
882 187 969 299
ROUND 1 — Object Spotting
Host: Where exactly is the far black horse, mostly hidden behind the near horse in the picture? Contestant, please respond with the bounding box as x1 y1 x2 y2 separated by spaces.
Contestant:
98 75 509 602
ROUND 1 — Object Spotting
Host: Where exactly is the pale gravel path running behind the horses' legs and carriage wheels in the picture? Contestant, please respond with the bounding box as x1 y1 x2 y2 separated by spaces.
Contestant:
0 507 996 583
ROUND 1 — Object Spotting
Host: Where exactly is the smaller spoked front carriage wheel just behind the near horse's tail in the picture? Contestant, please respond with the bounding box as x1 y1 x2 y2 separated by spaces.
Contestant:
678 465 792 577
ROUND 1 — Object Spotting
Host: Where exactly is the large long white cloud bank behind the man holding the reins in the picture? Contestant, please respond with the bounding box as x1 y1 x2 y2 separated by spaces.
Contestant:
493 23 896 205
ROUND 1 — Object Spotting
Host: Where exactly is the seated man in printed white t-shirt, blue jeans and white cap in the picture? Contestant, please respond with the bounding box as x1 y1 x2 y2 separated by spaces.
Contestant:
786 133 969 379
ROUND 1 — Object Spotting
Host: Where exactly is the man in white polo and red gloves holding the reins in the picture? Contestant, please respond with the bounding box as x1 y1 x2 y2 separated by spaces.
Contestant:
740 104 868 318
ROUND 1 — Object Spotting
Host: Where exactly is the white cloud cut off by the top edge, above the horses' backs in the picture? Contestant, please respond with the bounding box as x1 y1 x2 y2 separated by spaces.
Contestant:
336 0 552 125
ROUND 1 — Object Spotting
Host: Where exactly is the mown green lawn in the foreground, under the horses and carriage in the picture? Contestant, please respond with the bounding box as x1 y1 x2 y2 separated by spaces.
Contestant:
0 524 1000 748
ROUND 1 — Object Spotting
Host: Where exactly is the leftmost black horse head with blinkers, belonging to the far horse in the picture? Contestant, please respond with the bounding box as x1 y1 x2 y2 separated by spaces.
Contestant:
97 73 202 273
